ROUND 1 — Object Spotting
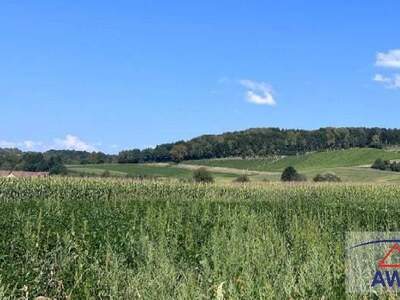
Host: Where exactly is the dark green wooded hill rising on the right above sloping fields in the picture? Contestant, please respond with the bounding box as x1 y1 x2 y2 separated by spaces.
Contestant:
118 127 400 163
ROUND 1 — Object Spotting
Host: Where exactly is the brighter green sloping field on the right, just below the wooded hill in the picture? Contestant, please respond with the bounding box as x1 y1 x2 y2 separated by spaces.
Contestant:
184 148 400 183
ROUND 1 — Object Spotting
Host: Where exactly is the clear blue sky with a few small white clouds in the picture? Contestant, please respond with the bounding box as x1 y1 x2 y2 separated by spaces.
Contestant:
0 0 400 153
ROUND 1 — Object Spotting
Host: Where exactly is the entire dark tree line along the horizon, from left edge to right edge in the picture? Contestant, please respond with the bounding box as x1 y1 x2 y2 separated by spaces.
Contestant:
0 127 400 172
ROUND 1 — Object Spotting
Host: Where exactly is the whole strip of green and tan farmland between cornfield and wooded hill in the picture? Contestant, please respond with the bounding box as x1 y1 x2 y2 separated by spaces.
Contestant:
68 148 400 183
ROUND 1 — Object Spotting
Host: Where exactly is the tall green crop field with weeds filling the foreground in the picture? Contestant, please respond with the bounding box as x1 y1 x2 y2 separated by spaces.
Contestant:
0 178 400 299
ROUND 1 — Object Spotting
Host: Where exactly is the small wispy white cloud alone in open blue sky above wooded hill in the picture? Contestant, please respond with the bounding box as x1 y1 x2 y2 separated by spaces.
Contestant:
239 79 276 106
